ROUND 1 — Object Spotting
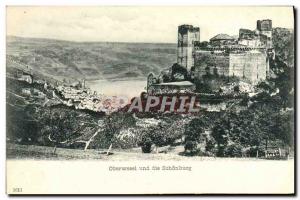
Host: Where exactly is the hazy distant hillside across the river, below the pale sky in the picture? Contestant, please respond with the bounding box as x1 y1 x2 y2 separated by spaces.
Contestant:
6 36 176 80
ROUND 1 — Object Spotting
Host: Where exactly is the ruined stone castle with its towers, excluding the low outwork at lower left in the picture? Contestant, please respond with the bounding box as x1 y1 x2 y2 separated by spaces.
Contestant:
177 19 275 85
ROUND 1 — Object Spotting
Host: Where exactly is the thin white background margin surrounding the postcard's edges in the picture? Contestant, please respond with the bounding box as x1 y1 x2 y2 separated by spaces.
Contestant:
0 0 300 199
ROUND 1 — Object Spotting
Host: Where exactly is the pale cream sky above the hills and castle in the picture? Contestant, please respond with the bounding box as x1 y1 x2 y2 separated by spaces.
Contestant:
6 6 294 43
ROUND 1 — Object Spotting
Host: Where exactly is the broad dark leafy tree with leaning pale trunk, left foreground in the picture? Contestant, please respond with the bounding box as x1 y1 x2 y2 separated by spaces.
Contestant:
35 106 100 153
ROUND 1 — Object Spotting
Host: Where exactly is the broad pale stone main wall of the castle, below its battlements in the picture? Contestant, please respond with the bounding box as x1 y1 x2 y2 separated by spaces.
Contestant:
194 50 268 84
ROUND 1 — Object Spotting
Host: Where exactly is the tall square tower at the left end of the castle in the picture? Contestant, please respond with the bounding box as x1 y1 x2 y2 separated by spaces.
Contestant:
177 24 200 72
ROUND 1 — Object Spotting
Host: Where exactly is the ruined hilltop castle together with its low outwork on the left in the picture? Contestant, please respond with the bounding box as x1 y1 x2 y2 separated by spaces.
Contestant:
147 19 275 94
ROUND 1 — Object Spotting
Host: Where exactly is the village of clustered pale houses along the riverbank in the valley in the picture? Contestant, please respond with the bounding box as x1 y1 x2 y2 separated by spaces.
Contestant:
8 57 126 113
